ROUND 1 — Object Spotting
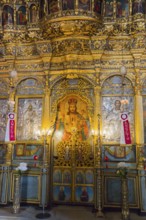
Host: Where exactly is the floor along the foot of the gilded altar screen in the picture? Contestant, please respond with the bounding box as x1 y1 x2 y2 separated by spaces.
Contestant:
0 205 146 220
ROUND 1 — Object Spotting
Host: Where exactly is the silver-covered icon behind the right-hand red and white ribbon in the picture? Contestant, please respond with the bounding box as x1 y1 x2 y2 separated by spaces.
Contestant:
102 97 134 143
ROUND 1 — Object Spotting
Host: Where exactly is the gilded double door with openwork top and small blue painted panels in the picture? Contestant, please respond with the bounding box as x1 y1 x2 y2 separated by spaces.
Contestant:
53 137 94 204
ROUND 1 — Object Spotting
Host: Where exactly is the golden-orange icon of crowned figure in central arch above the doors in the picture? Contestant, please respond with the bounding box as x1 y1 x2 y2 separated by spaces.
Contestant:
54 97 90 142
